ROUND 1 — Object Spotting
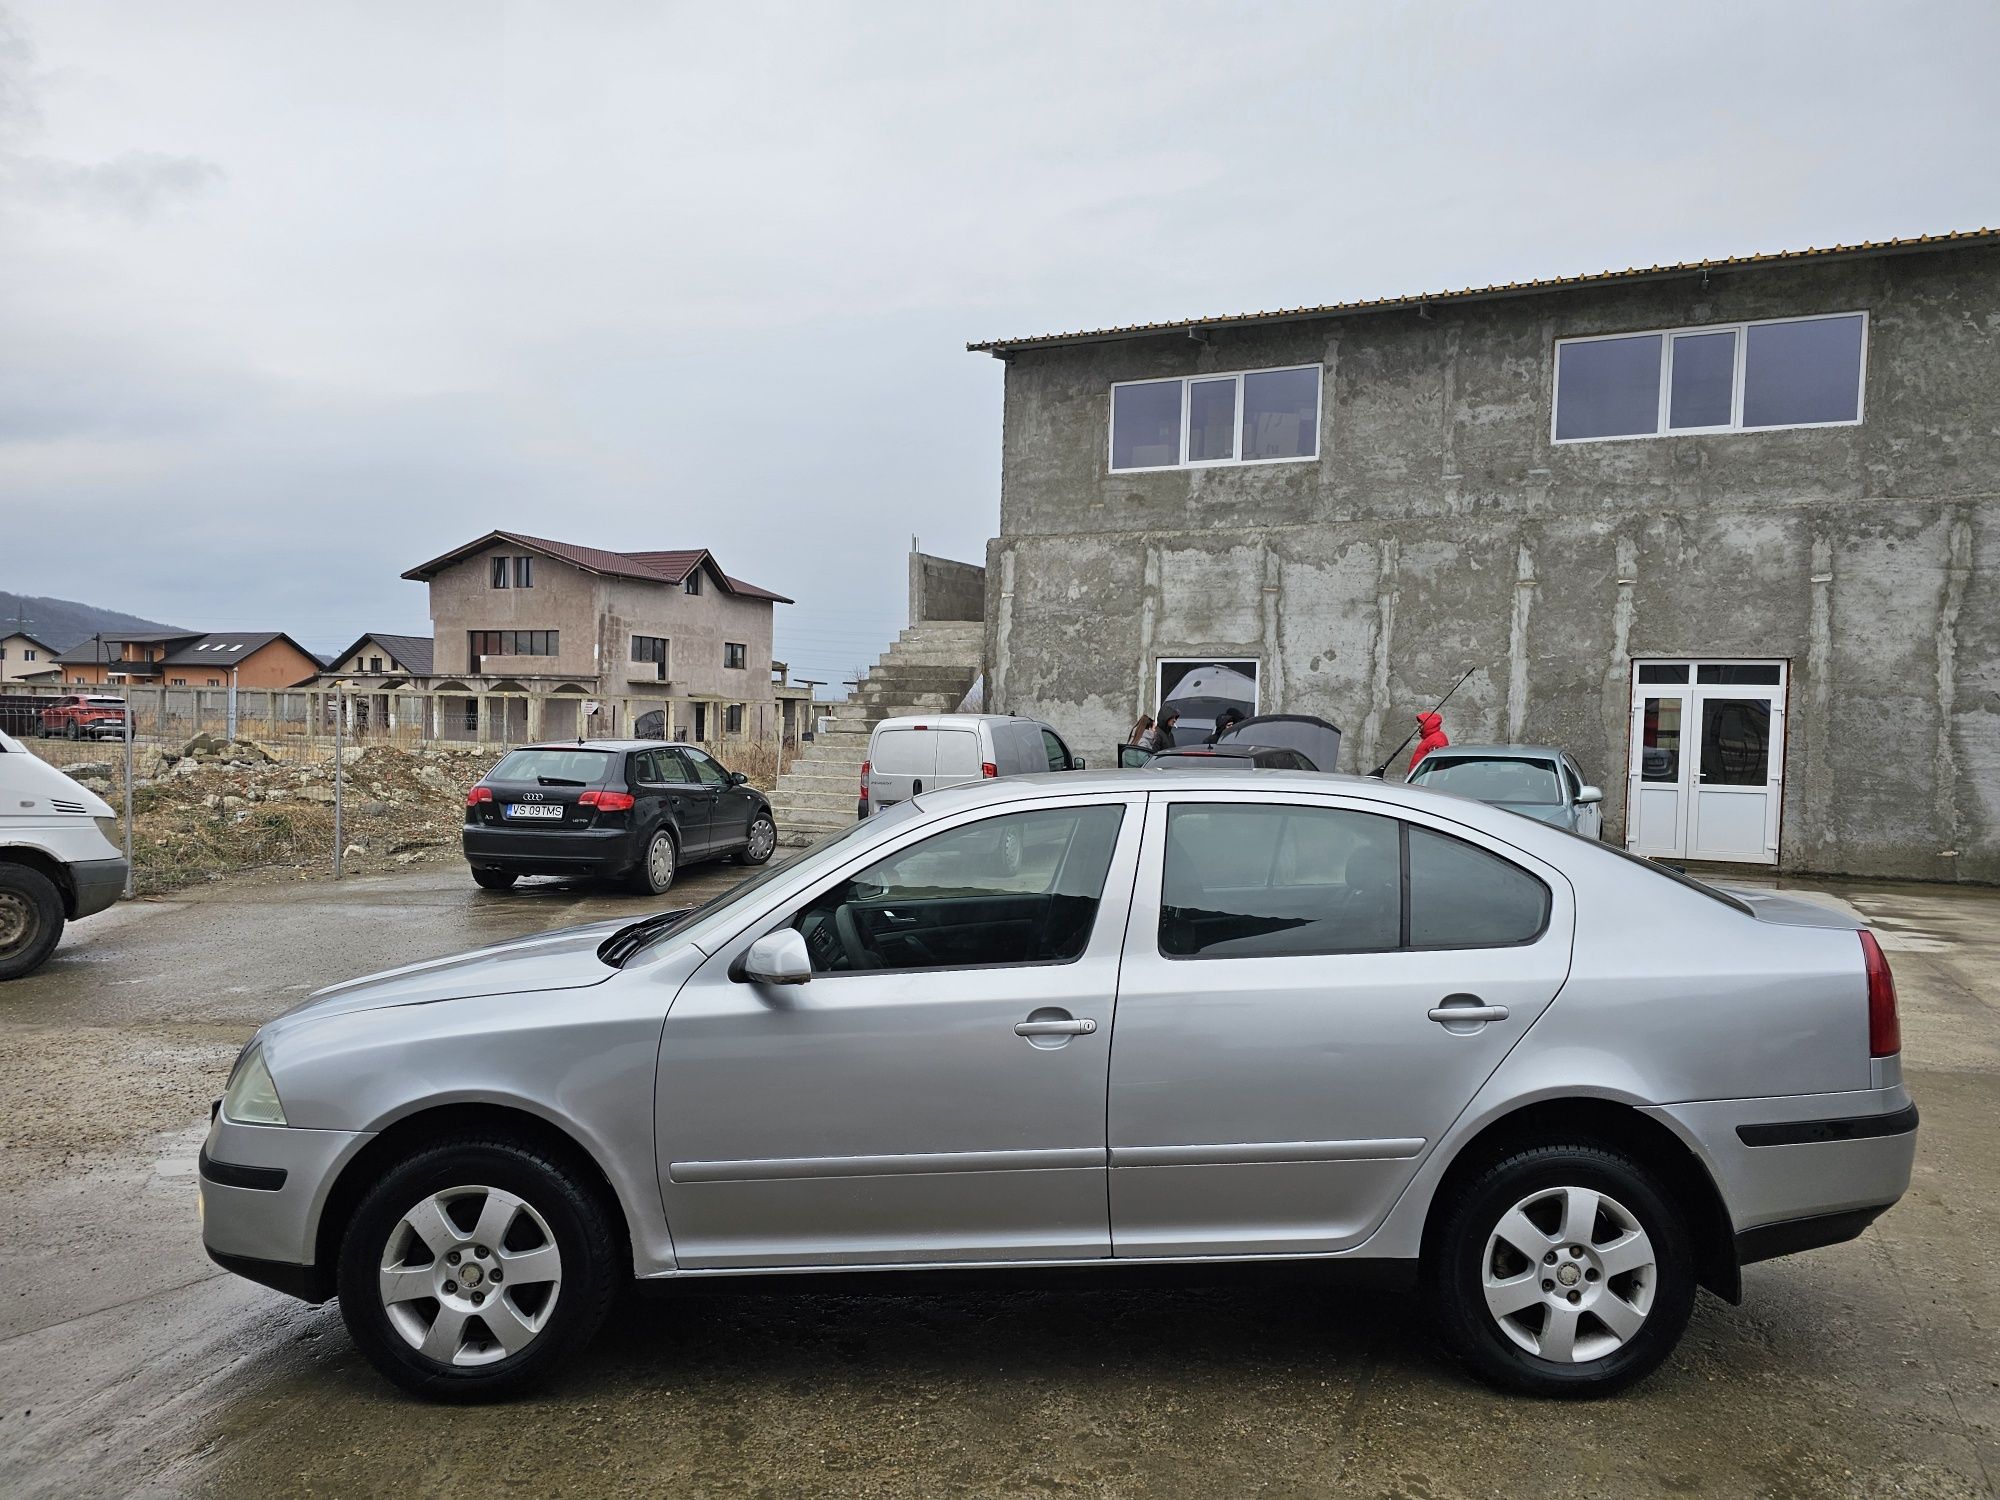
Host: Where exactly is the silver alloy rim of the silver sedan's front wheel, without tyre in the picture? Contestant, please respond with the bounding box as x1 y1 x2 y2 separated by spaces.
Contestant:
380 1186 562 1366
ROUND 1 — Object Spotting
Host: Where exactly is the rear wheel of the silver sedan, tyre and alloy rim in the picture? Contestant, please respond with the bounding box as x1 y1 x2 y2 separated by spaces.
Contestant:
1424 1142 1694 1396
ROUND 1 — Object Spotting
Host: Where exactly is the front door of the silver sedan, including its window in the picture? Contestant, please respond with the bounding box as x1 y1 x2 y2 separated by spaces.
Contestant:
656 796 1144 1268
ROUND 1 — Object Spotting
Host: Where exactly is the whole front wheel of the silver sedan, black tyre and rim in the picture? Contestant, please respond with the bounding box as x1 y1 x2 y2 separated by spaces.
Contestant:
338 1136 630 1400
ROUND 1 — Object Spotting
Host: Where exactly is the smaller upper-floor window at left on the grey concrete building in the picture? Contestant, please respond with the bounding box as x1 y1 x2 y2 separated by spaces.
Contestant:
1112 364 1320 470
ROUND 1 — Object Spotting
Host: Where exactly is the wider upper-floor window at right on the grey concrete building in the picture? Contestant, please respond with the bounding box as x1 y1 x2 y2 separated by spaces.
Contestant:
1554 312 1868 442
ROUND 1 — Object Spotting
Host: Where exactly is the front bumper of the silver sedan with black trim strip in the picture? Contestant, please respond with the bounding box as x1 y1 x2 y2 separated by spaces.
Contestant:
200 1112 372 1302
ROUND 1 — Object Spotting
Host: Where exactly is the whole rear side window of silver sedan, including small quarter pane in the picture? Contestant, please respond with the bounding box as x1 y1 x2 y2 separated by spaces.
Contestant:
1160 802 1550 958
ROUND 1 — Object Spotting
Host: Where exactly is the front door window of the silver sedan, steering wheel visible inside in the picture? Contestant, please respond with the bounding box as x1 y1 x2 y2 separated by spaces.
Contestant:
792 804 1124 974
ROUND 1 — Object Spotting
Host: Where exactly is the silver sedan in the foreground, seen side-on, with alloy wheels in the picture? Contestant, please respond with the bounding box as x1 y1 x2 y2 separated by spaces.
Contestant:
198 772 1916 1398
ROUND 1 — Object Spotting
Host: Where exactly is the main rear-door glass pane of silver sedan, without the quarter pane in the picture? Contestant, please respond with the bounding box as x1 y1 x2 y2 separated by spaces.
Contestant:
1160 802 1402 958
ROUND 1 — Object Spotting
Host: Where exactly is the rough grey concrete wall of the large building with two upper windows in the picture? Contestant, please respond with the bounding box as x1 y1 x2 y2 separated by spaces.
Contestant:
988 248 2000 880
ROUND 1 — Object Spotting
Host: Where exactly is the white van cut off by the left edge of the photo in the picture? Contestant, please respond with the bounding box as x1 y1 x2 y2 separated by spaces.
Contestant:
0 734 126 980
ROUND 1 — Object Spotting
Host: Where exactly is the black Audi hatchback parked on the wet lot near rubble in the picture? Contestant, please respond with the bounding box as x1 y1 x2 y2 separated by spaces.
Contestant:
464 740 778 896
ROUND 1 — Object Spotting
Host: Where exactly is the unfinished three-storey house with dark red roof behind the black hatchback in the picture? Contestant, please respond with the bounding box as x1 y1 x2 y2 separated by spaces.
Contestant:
404 532 792 742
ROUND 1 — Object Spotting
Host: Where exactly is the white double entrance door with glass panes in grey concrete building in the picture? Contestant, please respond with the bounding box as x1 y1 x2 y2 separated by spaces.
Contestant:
1626 662 1786 864
